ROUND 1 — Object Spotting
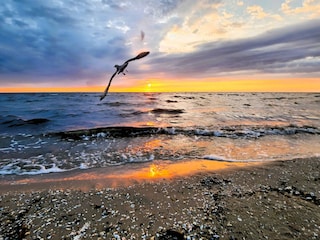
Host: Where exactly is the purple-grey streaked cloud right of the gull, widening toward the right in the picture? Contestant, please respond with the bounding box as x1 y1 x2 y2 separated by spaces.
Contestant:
151 20 320 77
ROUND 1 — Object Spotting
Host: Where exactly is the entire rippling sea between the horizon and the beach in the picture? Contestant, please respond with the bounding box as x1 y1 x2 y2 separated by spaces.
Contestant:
0 93 320 175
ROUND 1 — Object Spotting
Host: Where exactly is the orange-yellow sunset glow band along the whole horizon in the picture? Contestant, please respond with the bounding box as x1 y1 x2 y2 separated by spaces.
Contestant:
0 78 320 93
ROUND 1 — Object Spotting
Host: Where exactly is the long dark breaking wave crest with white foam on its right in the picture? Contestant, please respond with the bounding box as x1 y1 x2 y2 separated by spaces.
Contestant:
51 125 320 139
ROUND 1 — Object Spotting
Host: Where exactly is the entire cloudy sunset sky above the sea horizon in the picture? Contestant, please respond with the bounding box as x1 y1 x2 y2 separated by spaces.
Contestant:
0 0 320 92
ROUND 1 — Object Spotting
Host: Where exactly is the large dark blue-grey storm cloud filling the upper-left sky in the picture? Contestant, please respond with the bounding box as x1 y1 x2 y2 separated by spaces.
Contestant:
0 0 186 82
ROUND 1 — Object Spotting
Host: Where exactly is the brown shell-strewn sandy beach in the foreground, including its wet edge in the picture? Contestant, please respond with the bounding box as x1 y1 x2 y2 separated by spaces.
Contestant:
0 158 320 239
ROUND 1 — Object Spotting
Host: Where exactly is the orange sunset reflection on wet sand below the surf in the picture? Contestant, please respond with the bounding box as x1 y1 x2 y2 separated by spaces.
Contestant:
8 159 254 191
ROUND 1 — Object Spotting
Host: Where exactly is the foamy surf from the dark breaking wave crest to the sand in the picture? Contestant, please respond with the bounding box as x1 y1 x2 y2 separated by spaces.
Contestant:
0 125 320 175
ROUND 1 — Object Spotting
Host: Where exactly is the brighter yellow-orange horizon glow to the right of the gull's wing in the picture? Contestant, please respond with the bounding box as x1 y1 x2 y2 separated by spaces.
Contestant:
111 78 320 92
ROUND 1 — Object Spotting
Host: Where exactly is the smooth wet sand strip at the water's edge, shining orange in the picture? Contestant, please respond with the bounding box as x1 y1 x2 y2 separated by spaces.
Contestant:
0 159 255 194
